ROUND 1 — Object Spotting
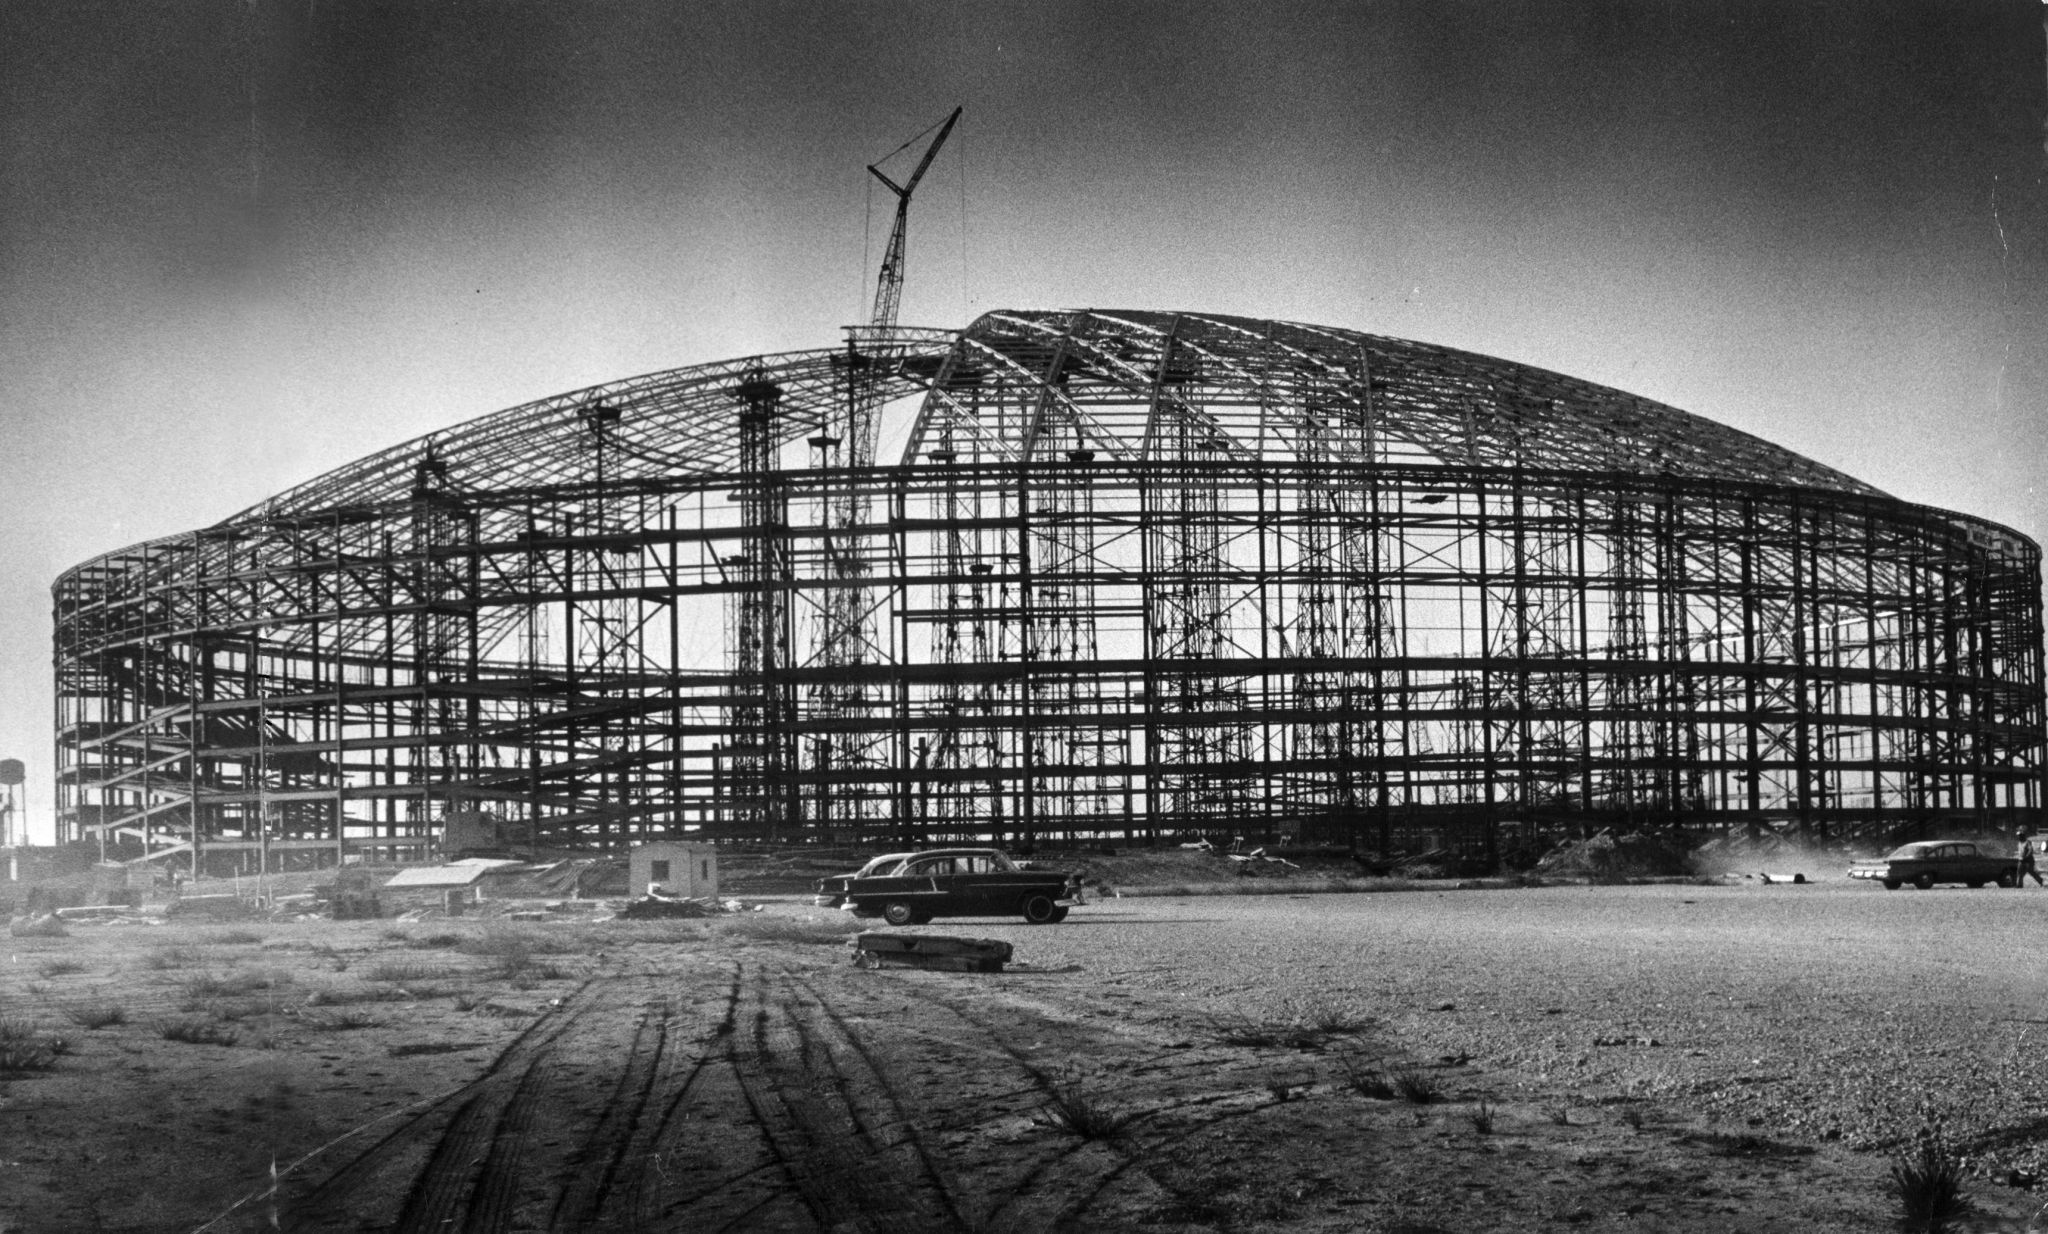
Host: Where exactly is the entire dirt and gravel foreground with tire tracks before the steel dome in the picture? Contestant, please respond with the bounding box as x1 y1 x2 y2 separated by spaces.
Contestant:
0 880 2048 1234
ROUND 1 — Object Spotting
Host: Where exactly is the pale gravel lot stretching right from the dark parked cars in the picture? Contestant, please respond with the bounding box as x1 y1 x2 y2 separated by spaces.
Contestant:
1001 880 2048 1173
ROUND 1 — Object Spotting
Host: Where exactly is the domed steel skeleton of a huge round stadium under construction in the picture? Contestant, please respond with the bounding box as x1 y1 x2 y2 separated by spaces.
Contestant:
53 311 2044 866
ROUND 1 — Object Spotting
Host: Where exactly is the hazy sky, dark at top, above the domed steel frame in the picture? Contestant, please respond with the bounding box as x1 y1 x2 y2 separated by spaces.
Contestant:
0 0 2048 837
